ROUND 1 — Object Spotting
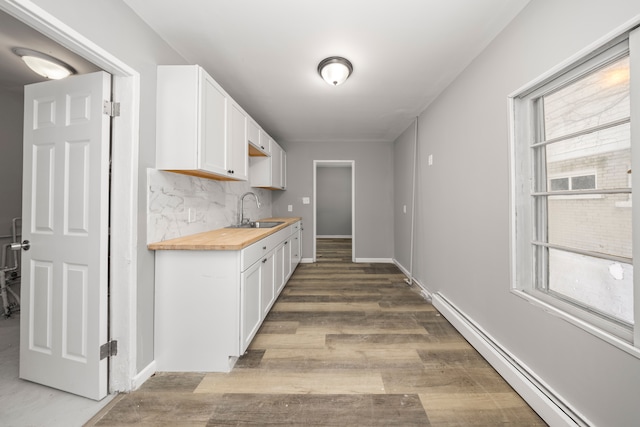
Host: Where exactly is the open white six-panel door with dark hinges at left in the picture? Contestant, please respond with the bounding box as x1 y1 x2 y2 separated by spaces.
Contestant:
20 72 111 400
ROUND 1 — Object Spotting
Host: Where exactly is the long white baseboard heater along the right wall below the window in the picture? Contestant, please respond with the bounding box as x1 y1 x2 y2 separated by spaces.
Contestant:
432 293 592 427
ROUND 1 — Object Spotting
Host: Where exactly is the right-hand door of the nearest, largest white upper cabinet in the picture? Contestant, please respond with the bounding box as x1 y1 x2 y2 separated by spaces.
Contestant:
227 102 249 181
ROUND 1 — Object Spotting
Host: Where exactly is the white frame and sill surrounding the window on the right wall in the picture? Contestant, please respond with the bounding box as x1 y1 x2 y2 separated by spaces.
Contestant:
508 23 640 358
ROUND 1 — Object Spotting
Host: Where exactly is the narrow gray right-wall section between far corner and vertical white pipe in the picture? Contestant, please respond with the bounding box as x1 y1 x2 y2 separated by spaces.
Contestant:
393 123 416 273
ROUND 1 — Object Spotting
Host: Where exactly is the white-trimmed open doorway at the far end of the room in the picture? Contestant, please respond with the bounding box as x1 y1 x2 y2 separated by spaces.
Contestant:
313 160 356 262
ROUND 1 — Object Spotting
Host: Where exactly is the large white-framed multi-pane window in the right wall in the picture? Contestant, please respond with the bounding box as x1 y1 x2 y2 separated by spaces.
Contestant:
511 26 640 347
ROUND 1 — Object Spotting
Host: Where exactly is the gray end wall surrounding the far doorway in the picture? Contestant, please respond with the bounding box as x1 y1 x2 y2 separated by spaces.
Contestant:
273 142 393 259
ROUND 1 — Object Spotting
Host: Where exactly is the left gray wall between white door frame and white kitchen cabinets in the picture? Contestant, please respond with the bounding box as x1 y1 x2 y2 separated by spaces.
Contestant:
29 0 186 370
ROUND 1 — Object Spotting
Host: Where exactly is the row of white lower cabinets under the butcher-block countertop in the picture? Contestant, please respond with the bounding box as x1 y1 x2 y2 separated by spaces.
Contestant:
154 222 301 372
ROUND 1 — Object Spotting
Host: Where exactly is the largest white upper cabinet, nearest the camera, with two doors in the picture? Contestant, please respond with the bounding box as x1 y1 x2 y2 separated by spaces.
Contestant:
156 65 248 181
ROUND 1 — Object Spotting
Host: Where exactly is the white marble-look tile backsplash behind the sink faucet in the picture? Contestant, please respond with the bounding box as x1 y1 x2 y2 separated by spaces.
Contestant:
147 169 272 243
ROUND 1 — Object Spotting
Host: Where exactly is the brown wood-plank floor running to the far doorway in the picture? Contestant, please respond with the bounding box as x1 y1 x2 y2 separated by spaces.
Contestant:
88 239 546 426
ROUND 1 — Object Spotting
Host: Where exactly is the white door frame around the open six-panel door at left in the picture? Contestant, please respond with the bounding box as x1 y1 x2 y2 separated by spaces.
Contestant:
0 0 141 394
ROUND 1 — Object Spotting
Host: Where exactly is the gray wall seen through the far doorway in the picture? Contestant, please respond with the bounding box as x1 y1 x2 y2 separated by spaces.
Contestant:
316 166 352 236
